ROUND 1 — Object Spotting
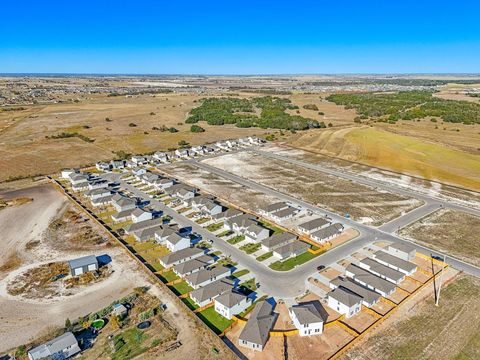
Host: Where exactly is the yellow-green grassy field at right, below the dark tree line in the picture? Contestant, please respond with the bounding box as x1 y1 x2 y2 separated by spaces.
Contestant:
289 123 480 190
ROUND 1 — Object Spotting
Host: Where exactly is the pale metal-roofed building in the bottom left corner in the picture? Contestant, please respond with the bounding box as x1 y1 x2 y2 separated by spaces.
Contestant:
28 332 81 360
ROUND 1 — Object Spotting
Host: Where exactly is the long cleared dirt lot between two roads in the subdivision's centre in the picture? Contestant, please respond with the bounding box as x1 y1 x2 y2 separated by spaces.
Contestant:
204 153 420 225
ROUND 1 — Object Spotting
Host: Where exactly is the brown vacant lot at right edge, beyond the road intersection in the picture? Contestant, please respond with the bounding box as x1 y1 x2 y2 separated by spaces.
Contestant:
400 209 480 266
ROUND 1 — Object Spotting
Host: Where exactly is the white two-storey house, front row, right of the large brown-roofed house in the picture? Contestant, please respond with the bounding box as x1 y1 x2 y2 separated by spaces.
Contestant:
288 301 328 336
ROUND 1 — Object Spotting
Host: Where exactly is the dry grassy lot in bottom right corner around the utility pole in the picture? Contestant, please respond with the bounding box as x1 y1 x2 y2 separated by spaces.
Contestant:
343 275 480 360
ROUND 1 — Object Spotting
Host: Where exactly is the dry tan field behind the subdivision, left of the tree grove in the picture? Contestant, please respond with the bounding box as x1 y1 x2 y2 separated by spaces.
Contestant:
0 94 274 181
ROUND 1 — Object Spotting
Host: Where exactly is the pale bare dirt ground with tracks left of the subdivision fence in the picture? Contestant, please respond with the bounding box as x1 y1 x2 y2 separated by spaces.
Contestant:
0 185 232 359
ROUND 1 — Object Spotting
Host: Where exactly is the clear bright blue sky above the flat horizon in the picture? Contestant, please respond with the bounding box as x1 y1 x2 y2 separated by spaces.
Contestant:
0 0 480 74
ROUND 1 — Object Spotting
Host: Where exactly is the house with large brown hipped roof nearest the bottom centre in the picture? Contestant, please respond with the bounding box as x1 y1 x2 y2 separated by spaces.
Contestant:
238 301 276 351
